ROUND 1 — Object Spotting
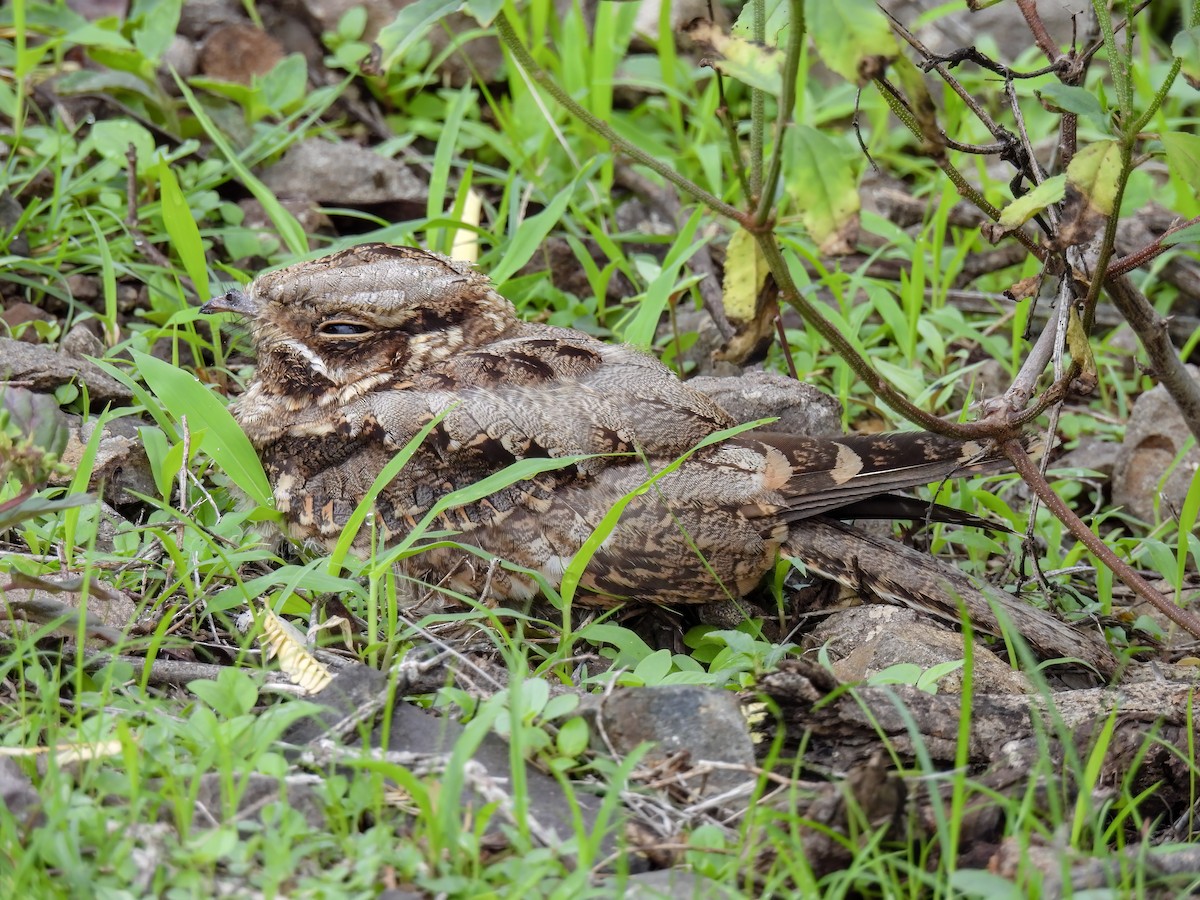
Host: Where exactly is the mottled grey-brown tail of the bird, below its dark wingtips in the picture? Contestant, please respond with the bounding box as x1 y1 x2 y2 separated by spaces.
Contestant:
781 518 1117 677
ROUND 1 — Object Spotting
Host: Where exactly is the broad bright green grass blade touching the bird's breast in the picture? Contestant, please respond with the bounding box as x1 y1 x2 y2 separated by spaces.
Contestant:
131 350 274 506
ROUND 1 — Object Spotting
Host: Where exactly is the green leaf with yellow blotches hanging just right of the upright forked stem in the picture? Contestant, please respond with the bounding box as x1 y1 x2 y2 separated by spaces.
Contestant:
784 125 860 254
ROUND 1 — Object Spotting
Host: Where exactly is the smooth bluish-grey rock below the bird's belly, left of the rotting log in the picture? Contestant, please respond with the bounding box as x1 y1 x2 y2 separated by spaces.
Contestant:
600 685 755 797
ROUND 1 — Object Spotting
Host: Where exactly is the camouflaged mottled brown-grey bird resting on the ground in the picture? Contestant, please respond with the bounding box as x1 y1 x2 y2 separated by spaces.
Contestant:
204 244 1111 670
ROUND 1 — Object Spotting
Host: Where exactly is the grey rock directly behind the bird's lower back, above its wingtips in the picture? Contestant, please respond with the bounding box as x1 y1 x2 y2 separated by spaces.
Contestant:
688 370 841 434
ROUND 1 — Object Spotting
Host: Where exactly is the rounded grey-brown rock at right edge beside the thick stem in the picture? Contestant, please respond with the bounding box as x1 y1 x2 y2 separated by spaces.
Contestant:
1112 366 1200 522
